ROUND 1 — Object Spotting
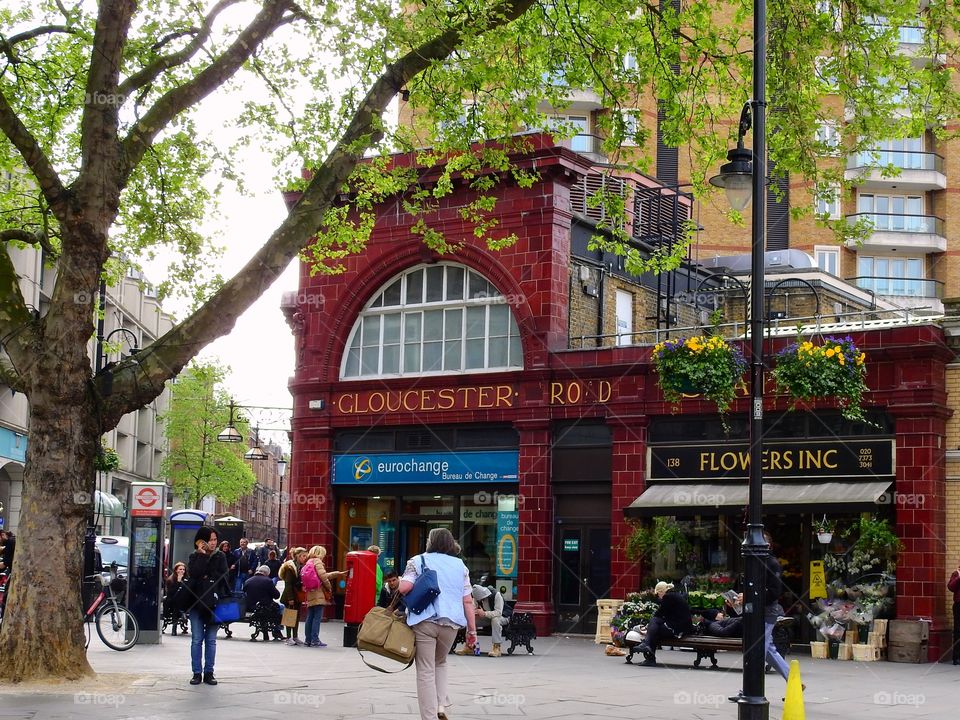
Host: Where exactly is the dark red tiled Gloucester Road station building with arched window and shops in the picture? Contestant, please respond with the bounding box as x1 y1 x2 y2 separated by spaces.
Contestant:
285 141 953 659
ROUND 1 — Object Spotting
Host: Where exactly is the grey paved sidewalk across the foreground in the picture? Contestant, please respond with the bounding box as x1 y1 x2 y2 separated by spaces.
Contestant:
0 622 960 720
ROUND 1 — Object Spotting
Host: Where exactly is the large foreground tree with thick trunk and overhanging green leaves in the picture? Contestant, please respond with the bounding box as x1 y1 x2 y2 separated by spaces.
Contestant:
0 0 960 682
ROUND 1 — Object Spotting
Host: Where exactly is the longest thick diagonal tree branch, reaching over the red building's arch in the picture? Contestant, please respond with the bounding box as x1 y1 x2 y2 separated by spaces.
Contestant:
104 0 536 427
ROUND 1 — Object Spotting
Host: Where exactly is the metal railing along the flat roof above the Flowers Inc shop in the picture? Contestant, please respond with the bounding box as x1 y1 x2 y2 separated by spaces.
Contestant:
569 307 943 350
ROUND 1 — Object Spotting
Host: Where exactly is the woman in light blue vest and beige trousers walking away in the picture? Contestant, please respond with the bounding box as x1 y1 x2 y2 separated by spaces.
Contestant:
400 528 477 720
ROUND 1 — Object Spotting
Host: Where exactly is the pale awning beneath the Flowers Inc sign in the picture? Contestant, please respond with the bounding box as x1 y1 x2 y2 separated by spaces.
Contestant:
624 480 892 517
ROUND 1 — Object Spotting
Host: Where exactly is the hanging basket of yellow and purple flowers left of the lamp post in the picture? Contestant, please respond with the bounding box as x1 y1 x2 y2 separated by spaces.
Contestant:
653 335 747 413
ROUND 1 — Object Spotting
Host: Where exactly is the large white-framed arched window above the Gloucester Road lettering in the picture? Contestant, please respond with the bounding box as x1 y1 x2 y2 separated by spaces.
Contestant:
340 263 523 379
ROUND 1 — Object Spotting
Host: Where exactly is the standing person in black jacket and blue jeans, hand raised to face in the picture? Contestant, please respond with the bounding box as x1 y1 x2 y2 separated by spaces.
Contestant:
187 525 230 685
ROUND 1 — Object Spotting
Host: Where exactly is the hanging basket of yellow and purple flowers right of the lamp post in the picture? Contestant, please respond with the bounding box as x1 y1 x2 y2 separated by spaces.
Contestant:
773 335 867 422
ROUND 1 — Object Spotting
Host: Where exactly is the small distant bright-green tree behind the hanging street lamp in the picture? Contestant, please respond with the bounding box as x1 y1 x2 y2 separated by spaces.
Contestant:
160 363 257 507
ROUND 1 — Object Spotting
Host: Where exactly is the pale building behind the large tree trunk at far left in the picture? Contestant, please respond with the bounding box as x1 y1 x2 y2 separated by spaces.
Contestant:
0 247 174 535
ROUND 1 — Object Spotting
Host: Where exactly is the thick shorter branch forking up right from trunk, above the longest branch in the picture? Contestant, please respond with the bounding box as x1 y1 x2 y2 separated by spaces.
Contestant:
121 0 296 185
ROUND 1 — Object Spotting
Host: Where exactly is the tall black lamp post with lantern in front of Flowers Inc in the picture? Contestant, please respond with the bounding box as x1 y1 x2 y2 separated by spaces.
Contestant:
710 0 770 720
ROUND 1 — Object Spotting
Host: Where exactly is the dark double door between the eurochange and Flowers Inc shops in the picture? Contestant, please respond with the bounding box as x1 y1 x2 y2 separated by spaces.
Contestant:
554 524 610 634
